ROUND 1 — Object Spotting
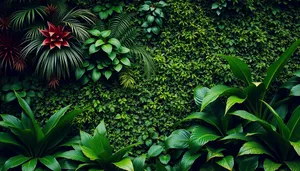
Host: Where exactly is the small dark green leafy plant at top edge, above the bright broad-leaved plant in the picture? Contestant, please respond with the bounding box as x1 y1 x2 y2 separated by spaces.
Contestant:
93 1 125 20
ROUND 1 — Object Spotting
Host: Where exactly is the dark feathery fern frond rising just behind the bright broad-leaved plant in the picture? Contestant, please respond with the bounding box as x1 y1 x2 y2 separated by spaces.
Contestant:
108 13 133 39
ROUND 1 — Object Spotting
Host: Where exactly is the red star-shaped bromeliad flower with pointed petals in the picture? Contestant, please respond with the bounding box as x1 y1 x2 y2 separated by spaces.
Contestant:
39 22 72 49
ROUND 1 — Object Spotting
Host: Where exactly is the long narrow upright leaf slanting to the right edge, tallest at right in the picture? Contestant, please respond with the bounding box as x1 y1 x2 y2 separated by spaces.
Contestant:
264 39 300 89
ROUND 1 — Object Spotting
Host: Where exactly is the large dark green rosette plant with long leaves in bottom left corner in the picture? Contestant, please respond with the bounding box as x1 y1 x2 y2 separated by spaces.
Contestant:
0 93 82 171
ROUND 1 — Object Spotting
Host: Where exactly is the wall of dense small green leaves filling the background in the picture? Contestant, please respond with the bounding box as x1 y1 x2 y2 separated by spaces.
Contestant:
0 0 300 153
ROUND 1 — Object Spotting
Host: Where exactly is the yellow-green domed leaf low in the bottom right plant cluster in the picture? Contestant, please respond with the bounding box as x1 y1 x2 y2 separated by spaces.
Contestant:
238 142 272 156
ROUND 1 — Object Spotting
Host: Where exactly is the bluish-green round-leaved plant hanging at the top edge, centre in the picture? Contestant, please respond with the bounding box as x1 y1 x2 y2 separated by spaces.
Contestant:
139 1 167 38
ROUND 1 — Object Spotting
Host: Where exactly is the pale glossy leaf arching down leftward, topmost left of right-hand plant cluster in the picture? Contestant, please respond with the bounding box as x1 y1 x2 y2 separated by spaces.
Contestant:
201 85 241 111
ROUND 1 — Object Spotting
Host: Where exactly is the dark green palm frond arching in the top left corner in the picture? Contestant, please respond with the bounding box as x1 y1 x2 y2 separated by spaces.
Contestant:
11 6 47 29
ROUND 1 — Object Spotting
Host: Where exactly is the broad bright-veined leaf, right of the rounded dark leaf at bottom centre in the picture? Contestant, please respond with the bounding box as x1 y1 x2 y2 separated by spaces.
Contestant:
190 125 220 152
